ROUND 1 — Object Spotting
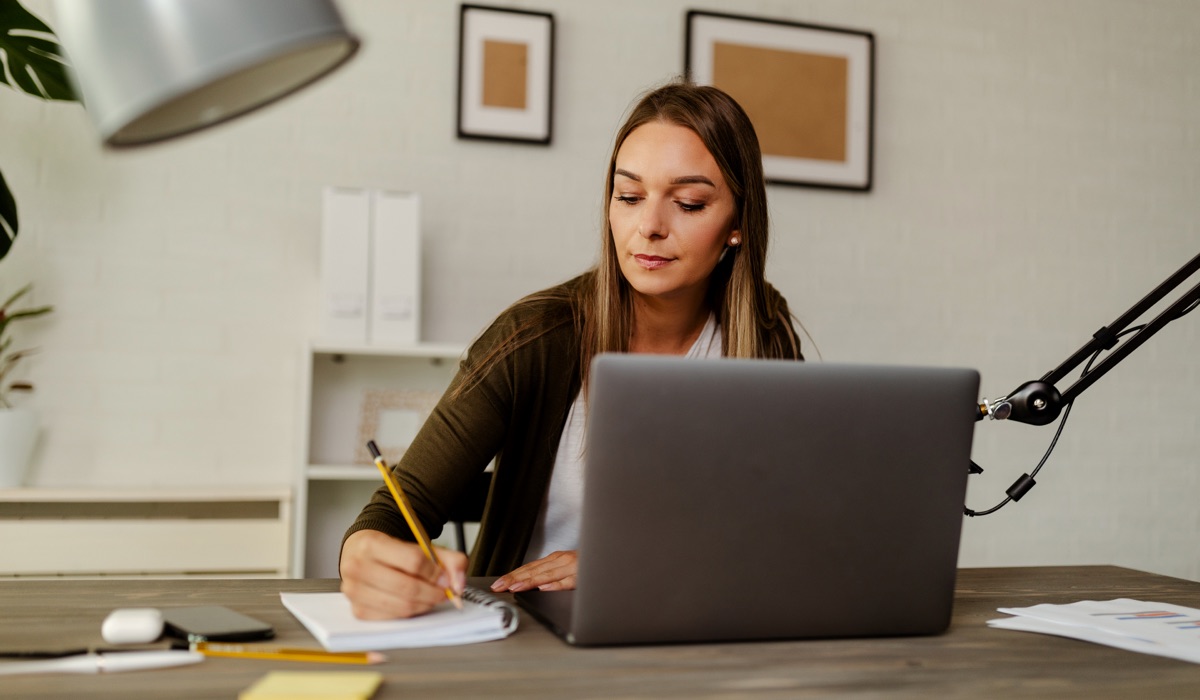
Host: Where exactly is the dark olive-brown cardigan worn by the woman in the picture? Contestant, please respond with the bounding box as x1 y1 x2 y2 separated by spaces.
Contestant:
346 273 799 576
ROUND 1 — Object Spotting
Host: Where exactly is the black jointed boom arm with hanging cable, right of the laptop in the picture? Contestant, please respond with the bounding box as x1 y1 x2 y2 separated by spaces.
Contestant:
964 255 1200 516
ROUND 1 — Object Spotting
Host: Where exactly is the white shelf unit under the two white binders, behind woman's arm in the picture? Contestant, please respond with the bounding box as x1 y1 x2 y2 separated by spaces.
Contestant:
292 343 466 578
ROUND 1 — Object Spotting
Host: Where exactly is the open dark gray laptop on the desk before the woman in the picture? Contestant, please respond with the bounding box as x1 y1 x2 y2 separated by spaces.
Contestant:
516 354 979 645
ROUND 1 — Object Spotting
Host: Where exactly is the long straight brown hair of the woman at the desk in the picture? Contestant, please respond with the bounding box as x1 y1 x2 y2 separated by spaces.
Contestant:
458 79 802 390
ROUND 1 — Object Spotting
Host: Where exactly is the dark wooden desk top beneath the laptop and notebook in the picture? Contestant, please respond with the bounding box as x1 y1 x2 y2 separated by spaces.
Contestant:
0 567 1200 700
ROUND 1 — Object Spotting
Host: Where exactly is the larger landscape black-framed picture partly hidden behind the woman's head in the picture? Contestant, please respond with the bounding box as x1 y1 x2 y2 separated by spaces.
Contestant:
684 11 875 191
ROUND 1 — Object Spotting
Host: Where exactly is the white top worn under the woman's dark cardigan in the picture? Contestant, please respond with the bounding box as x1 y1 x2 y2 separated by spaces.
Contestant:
524 313 721 562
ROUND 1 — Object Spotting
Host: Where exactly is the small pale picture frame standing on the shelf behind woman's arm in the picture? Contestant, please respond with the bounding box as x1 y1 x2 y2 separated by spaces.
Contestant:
354 389 442 465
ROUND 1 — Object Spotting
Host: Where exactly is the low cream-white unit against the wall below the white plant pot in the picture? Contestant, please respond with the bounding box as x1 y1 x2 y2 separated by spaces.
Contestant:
0 486 292 580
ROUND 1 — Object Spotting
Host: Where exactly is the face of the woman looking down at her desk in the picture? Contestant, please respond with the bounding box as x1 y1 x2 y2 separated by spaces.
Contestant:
608 121 738 300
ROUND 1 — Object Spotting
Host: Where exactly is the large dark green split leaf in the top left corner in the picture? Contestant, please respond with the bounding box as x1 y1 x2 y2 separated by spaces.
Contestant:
0 0 78 102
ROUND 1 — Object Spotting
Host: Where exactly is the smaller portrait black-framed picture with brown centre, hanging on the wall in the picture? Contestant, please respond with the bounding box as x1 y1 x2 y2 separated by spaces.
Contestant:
458 5 554 144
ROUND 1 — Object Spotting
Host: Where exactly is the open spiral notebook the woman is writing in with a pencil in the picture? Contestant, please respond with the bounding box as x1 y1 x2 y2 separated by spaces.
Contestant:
280 587 517 652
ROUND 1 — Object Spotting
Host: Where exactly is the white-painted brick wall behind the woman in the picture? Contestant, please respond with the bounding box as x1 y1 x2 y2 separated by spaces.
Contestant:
0 0 1200 579
